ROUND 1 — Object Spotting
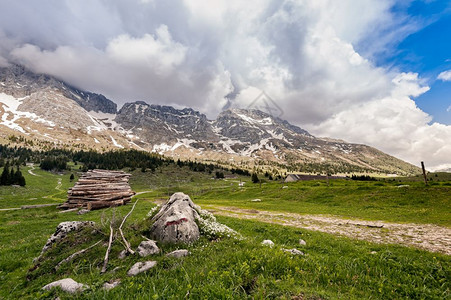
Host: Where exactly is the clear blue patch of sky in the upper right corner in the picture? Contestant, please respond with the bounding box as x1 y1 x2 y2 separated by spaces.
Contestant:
377 0 451 125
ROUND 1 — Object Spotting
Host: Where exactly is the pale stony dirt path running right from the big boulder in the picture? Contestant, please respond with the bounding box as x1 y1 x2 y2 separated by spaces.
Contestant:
204 205 451 255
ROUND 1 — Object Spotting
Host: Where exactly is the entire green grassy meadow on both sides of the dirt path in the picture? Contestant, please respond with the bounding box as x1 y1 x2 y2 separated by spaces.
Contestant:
0 167 451 299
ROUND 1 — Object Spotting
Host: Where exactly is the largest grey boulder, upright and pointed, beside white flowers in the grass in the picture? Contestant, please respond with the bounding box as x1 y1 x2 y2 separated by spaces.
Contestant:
151 193 200 243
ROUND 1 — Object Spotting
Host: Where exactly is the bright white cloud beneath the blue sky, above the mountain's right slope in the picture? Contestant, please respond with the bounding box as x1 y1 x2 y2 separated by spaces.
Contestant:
311 74 451 168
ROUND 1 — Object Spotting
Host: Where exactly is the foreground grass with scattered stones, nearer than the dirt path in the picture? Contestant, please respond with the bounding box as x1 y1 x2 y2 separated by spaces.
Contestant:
0 205 451 299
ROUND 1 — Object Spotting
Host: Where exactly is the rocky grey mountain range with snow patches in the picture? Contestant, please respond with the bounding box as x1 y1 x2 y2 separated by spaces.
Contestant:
0 65 419 174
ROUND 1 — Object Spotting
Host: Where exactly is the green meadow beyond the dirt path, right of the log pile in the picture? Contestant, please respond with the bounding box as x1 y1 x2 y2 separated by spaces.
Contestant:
125 168 451 227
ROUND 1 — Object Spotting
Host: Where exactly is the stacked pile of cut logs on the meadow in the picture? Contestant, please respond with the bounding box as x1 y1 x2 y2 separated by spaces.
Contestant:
60 169 135 210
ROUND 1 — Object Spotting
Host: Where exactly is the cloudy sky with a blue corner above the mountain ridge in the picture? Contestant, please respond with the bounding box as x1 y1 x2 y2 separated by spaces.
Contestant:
0 0 451 170
